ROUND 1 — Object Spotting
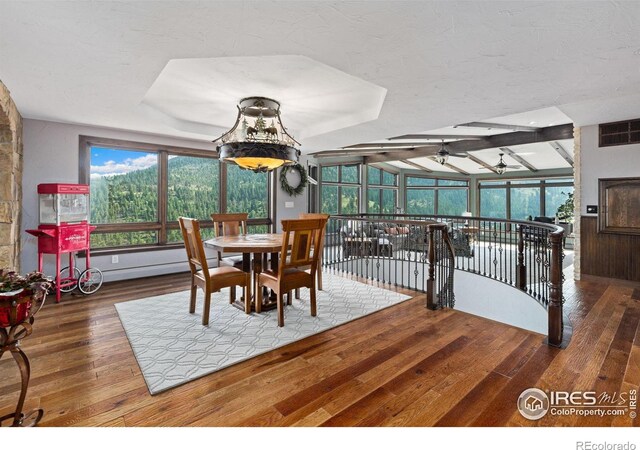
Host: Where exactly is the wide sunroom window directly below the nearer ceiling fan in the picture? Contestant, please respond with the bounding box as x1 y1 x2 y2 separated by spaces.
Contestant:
405 176 469 216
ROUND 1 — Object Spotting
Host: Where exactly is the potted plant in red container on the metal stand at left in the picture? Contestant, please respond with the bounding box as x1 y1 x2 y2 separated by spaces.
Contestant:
0 269 53 327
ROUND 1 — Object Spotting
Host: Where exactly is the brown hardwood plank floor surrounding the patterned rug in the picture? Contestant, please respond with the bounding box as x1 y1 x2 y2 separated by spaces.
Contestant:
0 268 640 426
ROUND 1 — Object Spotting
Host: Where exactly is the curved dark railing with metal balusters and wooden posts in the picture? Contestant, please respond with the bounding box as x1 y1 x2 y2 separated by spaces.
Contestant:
324 214 564 346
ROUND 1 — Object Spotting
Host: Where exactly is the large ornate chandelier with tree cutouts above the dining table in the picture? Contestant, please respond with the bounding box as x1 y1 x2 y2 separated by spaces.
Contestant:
213 97 300 172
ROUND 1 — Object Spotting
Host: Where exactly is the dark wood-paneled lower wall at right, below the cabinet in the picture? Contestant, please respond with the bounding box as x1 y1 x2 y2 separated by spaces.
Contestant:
580 216 640 281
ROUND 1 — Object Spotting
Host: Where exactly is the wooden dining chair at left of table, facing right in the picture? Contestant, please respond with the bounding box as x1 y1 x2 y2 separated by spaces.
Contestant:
179 217 251 325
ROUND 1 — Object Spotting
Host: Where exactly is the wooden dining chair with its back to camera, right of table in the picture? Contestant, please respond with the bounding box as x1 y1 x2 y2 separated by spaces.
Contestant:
256 219 327 327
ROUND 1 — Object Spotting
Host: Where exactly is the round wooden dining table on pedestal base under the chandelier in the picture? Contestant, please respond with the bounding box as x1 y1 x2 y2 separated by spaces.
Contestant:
204 233 283 312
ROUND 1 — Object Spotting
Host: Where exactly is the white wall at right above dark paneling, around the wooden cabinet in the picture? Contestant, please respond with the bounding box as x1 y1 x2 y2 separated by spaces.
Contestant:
580 125 640 215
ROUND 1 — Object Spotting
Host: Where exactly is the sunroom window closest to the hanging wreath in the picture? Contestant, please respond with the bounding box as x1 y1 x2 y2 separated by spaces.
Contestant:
320 164 360 215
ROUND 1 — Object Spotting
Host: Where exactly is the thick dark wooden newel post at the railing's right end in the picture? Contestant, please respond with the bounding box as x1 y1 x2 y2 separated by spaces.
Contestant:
548 231 564 347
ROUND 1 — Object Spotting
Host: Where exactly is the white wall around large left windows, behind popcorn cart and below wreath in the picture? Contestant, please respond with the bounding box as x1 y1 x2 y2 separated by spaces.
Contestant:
21 120 307 281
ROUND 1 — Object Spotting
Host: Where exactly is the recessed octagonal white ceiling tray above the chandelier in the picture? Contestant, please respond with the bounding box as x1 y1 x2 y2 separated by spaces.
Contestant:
142 55 387 140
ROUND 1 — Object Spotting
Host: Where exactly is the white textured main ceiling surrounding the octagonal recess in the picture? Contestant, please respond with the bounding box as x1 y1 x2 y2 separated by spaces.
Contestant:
0 1 640 151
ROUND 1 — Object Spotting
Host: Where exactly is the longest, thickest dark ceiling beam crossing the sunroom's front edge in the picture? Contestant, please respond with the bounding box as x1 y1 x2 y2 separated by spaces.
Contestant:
364 123 573 164
